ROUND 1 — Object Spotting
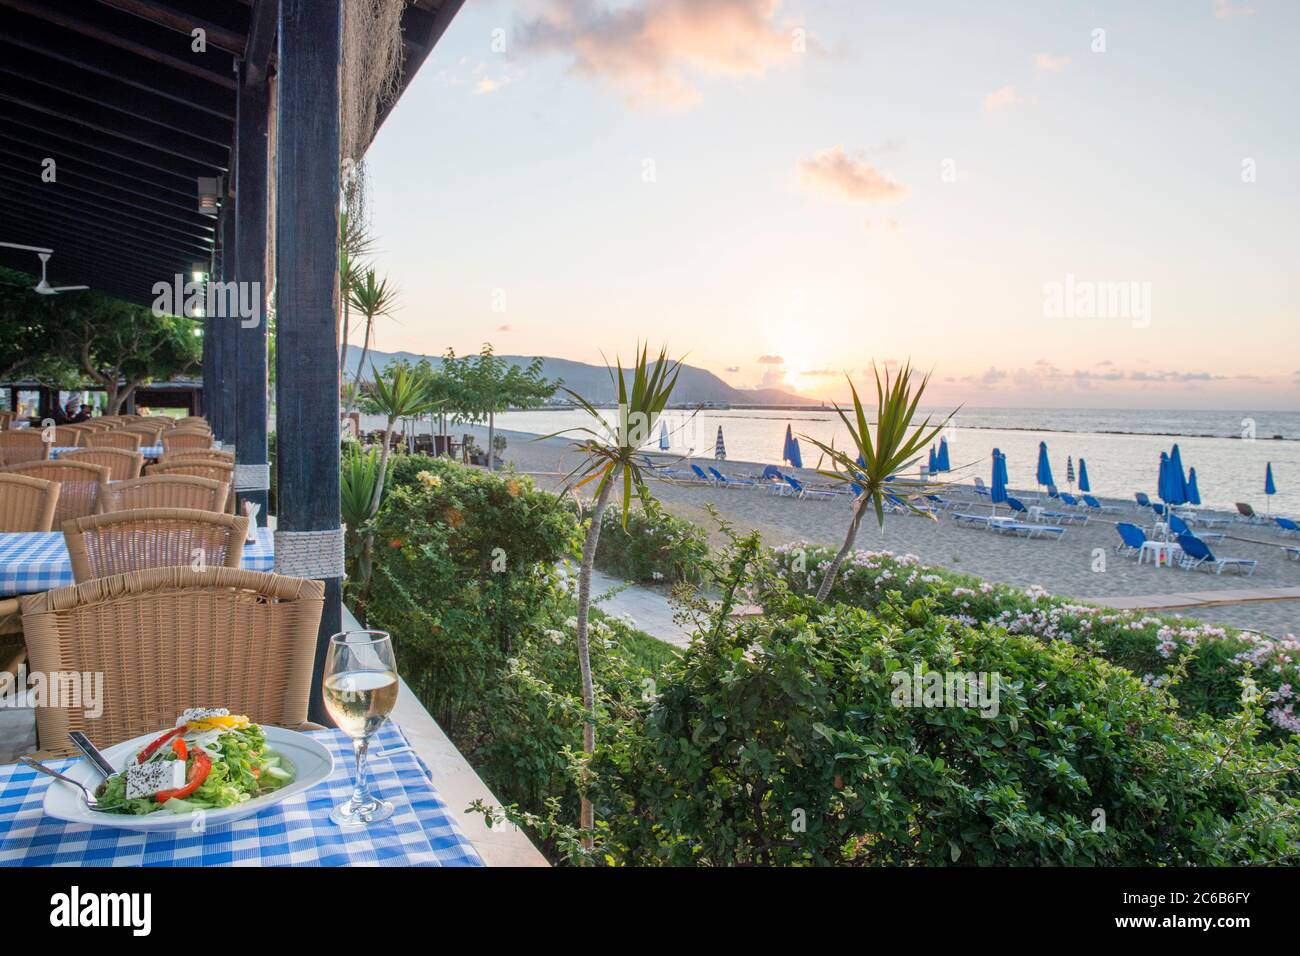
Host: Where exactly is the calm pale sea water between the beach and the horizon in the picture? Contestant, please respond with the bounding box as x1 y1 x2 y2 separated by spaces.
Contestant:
497 408 1300 514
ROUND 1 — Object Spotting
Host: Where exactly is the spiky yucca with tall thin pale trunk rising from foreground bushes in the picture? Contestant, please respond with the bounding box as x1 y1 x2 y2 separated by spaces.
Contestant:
546 346 681 848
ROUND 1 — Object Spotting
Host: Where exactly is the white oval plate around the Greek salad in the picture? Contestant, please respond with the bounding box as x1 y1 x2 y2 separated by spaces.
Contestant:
46 724 334 832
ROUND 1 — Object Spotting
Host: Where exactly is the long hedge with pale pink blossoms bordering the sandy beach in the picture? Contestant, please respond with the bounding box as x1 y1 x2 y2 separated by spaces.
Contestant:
774 542 1300 732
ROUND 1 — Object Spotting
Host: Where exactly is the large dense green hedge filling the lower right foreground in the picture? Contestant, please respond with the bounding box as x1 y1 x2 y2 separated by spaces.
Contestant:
594 598 1300 865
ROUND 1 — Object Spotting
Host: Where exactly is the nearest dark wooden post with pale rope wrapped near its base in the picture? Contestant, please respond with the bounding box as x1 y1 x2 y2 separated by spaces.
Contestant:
276 0 343 723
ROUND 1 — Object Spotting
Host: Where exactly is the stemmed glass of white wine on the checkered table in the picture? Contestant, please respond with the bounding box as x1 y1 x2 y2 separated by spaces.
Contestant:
324 631 398 829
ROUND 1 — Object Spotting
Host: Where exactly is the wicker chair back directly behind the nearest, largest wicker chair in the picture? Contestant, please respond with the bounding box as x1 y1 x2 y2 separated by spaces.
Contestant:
62 507 248 584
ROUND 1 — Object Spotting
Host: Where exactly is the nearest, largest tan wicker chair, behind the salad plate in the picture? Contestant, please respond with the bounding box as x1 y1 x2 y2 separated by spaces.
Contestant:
22 567 325 749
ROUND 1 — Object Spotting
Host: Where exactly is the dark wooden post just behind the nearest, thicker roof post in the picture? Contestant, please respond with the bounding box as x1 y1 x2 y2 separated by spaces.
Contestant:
235 75 270 525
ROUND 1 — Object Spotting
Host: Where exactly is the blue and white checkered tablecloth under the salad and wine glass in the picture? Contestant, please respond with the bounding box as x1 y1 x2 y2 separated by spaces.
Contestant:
0 722 484 866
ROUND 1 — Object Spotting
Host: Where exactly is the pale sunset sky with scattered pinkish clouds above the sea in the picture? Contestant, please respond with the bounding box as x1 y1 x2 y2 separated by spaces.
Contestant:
368 0 1300 410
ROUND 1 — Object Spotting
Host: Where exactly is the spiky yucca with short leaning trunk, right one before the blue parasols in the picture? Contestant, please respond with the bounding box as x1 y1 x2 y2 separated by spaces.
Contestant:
803 363 956 601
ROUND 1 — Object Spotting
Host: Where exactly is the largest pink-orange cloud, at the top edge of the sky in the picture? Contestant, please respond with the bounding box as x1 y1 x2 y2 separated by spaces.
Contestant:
519 0 798 108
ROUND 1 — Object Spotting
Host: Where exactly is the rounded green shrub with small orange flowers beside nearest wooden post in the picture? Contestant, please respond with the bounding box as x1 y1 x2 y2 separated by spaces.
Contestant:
348 455 577 736
